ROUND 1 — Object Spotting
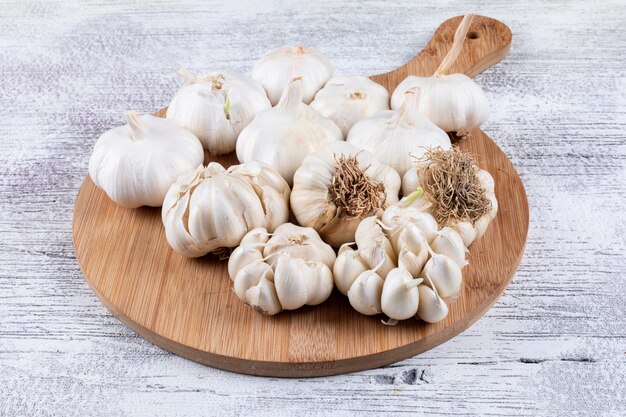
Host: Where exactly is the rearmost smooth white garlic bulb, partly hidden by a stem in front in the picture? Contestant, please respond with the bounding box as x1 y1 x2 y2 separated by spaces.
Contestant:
252 45 333 106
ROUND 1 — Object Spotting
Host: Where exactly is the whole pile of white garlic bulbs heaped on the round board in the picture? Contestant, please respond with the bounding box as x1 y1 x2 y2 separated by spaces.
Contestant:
89 15 497 323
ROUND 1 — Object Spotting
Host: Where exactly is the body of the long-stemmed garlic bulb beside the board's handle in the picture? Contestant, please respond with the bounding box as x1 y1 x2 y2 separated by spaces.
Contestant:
391 73 489 136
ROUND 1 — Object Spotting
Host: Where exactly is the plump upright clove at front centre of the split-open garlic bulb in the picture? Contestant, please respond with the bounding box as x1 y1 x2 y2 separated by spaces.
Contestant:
380 268 422 320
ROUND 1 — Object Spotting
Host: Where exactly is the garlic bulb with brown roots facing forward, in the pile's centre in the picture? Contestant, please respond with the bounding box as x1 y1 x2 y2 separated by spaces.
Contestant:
291 141 400 247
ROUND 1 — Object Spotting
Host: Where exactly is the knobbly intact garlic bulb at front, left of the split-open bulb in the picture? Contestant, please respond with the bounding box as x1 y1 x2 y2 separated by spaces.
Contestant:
228 223 335 315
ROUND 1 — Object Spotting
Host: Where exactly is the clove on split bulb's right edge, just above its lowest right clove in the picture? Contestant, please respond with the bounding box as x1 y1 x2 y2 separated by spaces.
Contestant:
420 253 463 301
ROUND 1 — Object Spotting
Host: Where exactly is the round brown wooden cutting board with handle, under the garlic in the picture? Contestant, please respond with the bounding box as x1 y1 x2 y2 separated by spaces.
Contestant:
73 16 528 377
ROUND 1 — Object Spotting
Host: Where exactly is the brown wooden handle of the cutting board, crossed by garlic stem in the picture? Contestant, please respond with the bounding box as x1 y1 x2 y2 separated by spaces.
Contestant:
370 15 512 93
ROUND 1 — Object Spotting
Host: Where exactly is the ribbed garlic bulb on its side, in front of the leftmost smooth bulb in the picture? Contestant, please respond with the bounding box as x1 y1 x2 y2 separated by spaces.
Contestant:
162 161 289 257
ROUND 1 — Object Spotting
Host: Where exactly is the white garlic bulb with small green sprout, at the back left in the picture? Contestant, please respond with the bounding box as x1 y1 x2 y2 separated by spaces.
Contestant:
166 70 272 155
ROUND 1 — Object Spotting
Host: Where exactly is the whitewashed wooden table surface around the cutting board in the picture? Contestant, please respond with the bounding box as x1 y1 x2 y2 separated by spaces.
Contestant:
0 0 626 417
